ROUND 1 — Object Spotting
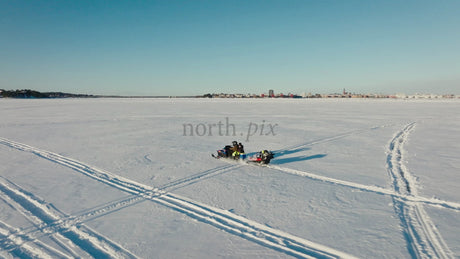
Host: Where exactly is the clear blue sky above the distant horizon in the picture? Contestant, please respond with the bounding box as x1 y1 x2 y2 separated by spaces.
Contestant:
0 0 460 95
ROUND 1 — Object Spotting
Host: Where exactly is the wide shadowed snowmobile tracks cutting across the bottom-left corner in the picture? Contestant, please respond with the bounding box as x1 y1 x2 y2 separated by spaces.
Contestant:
0 178 136 258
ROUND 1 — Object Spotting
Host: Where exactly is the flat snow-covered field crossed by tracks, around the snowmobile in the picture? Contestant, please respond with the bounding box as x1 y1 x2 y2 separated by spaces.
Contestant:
0 99 460 258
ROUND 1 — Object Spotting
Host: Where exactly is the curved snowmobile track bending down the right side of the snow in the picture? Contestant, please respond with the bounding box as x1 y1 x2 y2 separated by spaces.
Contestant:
387 123 454 258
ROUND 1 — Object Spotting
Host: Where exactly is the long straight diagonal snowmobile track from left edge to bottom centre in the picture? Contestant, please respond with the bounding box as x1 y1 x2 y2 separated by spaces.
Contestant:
0 138 354 258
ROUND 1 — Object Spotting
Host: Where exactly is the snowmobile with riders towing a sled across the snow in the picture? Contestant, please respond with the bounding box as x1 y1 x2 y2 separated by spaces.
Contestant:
213 141 275 164
